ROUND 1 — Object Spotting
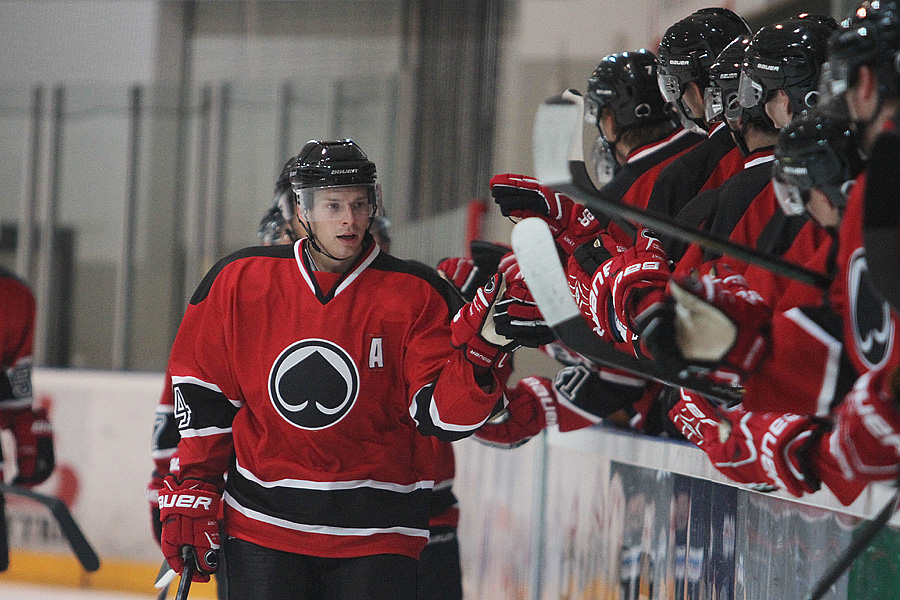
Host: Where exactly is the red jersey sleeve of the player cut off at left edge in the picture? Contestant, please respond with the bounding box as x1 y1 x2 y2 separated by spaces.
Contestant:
0 268 36 410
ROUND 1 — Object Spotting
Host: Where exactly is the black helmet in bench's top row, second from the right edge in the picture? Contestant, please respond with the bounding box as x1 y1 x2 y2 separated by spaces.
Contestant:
739 14 837 114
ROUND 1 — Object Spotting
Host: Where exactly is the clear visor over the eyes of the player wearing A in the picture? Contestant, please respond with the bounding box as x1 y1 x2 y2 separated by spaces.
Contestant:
297 184 381 221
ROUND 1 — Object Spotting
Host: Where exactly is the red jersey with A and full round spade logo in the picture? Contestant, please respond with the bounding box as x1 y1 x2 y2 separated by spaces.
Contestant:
170 241 501 557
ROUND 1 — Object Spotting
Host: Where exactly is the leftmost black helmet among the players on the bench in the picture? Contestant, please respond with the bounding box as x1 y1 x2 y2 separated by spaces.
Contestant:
585 48 673 131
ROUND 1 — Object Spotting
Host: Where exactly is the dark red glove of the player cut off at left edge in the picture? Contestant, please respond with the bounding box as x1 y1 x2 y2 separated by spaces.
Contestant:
2 408 56 487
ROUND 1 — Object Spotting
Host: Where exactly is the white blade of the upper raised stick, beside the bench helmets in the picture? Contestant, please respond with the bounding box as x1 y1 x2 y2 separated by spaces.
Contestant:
532 96 584 186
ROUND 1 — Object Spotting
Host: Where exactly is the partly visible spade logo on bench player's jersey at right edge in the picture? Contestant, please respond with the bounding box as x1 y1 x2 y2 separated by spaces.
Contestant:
847 248 894 369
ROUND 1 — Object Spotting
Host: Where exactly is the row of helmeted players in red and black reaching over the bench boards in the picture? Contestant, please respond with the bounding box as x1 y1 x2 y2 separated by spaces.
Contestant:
464 1 900 504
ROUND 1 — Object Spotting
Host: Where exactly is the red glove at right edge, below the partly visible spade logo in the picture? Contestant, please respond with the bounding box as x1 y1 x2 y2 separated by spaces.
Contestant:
831 368 900 482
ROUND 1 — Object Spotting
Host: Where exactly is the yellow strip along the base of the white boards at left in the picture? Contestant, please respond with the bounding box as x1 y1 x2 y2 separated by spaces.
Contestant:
0 550 216 599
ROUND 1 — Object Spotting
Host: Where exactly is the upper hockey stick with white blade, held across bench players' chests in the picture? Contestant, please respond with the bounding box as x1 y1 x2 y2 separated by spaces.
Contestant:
534 93 831 289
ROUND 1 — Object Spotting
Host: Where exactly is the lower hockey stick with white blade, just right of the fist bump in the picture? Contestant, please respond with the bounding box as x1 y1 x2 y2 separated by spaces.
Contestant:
512 217 742 403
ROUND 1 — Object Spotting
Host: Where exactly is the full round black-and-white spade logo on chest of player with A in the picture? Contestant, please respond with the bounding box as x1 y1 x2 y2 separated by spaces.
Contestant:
269 339 359 429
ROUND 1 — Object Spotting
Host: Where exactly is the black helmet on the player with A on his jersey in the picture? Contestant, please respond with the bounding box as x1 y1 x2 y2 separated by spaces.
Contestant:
290 139 381 217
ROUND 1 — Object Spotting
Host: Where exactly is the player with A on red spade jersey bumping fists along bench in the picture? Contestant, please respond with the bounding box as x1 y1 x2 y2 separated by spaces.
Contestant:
159 140 539 600
